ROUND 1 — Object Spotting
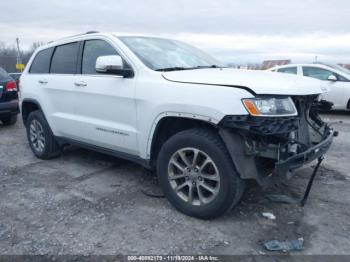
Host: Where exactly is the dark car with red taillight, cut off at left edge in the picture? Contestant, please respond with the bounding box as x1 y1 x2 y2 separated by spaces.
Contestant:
0 67 19 125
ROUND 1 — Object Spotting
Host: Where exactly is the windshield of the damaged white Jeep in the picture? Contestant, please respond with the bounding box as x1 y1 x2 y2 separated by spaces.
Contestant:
119 36 222 71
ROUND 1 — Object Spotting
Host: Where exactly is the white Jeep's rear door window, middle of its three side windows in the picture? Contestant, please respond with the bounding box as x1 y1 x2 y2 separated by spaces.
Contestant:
50 42 79 74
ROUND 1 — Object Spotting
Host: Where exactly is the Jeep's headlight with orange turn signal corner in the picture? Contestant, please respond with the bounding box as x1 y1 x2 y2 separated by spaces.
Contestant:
242 97 298 116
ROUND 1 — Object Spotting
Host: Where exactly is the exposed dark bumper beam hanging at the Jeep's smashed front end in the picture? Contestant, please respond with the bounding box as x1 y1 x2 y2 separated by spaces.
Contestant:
273 127 334 176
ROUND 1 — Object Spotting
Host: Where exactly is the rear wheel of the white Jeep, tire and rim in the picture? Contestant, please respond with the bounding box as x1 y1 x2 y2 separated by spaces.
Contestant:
26 111 61 159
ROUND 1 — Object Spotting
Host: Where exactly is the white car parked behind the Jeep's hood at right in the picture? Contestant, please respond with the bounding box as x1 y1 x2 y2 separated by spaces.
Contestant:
268 63 350 110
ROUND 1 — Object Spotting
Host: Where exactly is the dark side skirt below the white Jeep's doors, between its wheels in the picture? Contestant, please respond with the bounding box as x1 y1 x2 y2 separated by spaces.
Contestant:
55 137 151 169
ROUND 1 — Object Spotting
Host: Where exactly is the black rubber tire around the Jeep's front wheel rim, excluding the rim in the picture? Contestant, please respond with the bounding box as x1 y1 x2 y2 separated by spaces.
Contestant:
157 128 245 219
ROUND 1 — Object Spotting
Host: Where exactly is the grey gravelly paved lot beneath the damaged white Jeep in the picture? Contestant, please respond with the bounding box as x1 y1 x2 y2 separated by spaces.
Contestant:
0 113 350 254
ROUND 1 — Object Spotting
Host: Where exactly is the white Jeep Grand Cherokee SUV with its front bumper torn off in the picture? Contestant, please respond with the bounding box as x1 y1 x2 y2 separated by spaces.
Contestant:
20 32 334 219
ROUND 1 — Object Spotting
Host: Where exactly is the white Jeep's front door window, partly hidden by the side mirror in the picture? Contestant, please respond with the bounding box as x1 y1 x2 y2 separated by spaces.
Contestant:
81 40 118 74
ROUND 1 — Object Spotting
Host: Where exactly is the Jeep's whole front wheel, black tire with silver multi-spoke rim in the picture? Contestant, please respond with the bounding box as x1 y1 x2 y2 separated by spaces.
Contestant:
157 129 244 219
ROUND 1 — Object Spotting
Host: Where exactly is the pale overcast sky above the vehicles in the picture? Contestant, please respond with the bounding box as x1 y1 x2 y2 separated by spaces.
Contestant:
0 0 350 64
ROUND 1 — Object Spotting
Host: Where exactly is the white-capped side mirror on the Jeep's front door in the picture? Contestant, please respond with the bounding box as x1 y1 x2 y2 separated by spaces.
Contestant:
95 55 133 77
